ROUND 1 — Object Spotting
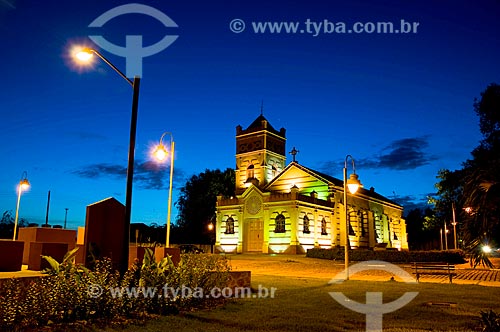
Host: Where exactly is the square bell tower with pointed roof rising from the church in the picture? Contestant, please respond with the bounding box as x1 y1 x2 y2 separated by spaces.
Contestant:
236 114 286 194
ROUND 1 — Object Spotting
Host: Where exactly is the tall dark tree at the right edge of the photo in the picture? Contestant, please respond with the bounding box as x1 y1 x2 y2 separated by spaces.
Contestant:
435 84 500 267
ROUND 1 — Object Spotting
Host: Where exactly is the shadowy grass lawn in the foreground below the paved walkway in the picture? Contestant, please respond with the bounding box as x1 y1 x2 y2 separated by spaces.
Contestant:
107 275 500 332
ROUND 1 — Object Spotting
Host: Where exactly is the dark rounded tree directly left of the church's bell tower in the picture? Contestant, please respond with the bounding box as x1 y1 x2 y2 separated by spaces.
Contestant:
176 168 235 243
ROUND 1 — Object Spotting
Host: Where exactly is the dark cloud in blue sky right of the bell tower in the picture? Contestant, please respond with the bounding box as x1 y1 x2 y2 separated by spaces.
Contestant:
322 136 437 171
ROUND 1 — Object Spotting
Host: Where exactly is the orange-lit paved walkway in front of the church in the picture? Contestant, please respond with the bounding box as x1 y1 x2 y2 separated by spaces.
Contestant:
228 254 500 287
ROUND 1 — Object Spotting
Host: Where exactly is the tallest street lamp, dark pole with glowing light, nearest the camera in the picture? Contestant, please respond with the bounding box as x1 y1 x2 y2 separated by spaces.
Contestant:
75 48 141 274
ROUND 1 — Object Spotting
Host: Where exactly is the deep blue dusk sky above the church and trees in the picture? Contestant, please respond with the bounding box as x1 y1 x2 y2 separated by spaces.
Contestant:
0 0 500 228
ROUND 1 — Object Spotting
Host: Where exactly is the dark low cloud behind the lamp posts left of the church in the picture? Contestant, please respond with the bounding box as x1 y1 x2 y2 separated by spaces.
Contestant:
72 161 185 190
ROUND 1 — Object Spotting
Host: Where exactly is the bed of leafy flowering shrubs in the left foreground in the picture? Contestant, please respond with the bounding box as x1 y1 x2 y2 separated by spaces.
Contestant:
0 249 229 331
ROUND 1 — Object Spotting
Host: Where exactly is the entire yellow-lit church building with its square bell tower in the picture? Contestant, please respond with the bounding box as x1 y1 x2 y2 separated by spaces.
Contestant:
215 115 408 254
